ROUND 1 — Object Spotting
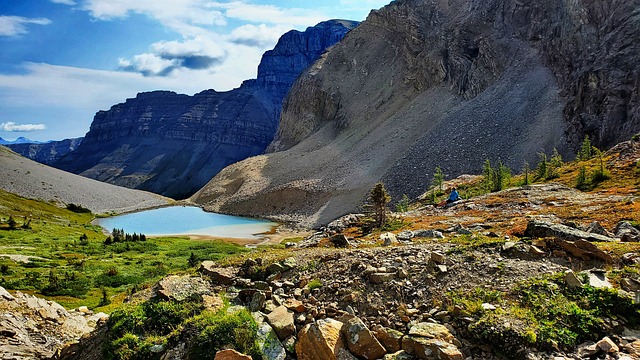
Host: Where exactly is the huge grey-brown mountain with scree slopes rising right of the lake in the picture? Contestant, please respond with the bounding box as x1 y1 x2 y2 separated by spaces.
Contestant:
192 0 640 226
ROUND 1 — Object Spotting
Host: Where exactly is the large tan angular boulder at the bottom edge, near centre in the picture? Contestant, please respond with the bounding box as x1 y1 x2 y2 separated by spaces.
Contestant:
296 319 348 360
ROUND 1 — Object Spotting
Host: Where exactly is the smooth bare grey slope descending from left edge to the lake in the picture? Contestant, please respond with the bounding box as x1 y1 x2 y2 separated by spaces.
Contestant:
0 146 171 214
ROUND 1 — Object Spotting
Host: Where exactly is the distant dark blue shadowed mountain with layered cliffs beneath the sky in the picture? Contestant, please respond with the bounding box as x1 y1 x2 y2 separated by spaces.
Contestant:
55 20 356 198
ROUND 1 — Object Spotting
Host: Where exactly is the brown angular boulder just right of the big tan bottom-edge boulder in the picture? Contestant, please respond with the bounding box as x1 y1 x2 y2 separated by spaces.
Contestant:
341 317 387 360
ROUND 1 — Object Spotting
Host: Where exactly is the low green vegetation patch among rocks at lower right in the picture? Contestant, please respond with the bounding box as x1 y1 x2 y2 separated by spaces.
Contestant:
447 273 640 354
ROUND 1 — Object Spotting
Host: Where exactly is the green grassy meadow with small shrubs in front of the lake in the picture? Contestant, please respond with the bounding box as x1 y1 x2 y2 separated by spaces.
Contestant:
0 190 248 310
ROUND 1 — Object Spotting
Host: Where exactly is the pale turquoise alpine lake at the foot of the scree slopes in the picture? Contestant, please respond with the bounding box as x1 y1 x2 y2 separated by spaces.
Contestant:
97 206 278 239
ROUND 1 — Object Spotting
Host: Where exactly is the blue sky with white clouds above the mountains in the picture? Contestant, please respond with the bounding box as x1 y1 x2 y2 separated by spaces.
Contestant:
0 0 390 141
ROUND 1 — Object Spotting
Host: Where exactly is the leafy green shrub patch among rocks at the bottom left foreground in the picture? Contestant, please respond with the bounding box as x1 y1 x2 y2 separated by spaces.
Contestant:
103 298 262 360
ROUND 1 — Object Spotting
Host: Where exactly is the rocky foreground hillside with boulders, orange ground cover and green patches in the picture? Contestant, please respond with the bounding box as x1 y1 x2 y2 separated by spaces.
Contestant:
58 141 640 360
